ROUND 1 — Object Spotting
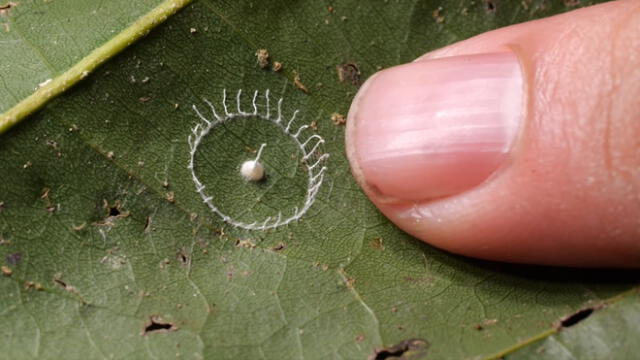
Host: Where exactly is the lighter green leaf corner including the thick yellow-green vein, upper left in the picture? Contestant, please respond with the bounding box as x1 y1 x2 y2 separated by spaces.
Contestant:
0 0 191 134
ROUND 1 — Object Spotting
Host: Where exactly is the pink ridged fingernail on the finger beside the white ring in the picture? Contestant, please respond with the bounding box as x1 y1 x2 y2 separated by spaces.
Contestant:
348 52 524 200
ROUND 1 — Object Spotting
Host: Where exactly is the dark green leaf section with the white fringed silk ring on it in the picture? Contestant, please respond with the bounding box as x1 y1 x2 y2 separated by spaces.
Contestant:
0 0 637 359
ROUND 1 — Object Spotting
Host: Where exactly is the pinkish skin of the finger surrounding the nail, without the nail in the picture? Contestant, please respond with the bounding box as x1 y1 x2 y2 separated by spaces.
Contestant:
346 0 640 267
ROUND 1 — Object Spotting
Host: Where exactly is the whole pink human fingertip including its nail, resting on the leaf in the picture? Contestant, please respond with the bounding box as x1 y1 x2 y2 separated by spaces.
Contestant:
346 1 640 267
